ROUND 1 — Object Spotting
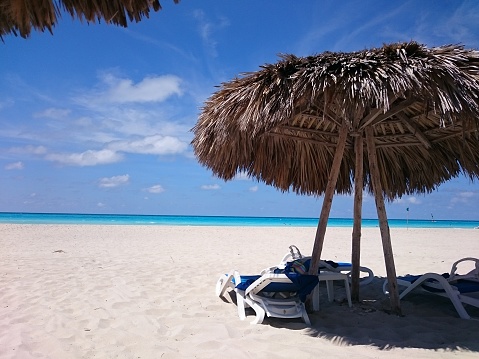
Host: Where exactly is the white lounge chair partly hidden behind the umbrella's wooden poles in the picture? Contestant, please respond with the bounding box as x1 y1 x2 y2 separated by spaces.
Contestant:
277 245 374 286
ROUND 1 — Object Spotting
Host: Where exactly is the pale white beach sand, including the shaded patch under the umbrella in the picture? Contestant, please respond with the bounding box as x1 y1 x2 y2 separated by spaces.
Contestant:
0 224 479 359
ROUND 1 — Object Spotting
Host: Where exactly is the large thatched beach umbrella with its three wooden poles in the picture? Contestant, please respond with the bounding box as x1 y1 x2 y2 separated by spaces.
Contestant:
192 42 479 314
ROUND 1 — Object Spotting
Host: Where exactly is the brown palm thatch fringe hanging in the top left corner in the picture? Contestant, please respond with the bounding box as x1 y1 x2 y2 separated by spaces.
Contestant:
0 0 179 38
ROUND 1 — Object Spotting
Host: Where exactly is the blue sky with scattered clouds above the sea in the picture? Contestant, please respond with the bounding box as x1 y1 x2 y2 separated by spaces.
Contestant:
0 0 479 220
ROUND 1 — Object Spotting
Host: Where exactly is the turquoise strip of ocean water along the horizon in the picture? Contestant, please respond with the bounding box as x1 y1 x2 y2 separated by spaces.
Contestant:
0 212 479 228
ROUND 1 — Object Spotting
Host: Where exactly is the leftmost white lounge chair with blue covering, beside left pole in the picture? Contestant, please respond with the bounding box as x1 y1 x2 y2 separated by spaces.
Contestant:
216 271 318 326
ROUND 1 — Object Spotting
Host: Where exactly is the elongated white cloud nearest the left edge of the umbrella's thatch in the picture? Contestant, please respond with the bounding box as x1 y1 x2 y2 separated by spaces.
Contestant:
108 135 188 155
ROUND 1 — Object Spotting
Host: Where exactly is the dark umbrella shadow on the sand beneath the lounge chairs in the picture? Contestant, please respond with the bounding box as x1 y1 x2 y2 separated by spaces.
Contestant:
265 277 479 352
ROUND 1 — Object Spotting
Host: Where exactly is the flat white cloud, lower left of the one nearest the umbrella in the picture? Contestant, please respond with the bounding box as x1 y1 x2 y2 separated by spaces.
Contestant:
45 149 123 167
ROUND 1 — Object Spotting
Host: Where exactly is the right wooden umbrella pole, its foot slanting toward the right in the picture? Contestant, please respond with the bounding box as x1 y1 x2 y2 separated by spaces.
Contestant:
365 126 401 315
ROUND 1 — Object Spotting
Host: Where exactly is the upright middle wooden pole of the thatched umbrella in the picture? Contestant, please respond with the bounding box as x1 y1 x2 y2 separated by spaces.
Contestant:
351 132 364 302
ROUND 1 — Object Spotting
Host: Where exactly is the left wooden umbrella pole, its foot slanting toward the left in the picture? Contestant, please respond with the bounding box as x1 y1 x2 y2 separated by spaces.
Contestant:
309 123 348 274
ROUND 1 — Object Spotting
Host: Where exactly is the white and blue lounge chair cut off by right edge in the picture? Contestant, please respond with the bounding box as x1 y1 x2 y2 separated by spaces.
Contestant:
383 257 479 319
